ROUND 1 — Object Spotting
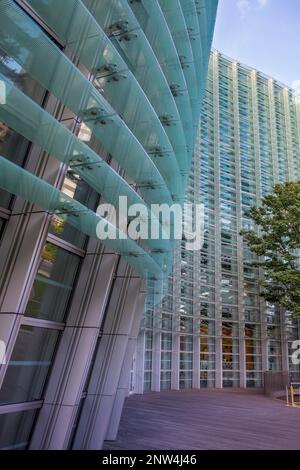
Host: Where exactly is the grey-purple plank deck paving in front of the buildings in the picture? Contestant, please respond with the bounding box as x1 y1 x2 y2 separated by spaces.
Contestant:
105 390 300 450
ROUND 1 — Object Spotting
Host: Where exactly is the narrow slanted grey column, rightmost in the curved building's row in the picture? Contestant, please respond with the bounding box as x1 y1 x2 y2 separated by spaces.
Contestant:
106 290 146 441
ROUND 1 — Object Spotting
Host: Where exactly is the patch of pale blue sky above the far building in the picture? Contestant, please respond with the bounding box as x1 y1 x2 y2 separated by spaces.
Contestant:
213 0 300 90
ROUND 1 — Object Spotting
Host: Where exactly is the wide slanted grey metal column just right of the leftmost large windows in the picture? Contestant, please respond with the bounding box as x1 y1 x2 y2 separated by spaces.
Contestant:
31 244 118 450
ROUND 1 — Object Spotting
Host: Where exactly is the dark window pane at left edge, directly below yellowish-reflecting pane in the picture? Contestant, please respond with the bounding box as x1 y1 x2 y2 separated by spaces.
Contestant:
0 325 59 403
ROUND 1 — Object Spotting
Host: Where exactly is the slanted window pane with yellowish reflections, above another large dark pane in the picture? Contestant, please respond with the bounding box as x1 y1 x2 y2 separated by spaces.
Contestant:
25 243 80 322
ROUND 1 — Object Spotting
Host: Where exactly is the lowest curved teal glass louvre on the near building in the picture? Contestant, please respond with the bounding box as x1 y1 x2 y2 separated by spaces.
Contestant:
0 151 171 303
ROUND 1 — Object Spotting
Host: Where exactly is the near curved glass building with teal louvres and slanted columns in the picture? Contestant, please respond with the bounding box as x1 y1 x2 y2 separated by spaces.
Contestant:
0 0 218 449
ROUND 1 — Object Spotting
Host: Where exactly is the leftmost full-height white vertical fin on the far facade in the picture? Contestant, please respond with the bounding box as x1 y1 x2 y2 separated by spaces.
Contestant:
212 52 223 388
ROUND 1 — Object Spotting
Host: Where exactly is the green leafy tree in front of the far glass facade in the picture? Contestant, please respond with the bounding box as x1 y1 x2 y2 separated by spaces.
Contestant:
241 181 300 317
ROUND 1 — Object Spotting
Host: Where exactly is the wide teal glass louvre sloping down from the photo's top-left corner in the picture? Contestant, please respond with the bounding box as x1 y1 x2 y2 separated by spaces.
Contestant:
0 1 176 207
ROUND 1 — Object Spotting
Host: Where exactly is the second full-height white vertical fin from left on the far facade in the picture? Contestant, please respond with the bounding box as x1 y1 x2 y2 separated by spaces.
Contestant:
232 62 246 388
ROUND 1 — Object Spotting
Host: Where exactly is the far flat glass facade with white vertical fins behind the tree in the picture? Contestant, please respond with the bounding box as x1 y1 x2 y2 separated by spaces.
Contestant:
135 51 300 391
